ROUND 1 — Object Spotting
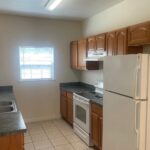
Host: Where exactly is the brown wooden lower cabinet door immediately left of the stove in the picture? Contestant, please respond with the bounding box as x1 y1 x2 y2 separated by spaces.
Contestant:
67 92 73 125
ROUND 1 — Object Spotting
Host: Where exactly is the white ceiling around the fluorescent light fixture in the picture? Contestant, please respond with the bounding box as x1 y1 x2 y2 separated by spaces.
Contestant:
0 0 123 20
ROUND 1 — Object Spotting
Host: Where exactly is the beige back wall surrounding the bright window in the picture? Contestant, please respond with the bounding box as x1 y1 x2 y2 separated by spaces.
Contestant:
0 15 82 121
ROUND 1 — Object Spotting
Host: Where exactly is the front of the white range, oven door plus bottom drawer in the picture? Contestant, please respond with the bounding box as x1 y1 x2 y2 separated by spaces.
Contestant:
73 93 91 146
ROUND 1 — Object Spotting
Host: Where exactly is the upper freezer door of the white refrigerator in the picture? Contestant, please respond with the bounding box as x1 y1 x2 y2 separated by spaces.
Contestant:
104 54 149 99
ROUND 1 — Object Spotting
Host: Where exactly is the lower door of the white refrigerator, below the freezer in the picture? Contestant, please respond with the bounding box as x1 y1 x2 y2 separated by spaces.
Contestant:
103 92 147 150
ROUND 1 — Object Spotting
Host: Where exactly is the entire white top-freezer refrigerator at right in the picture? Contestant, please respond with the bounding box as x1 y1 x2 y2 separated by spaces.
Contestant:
103 54 150 150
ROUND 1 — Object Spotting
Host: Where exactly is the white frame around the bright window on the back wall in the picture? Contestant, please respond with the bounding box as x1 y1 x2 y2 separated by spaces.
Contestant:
19 46 55 82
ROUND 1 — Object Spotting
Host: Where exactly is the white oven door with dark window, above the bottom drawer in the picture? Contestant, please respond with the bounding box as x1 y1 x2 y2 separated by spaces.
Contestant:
73 98 90 133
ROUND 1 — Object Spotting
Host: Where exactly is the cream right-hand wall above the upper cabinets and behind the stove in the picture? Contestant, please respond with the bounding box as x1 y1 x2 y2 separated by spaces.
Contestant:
81 0 150 83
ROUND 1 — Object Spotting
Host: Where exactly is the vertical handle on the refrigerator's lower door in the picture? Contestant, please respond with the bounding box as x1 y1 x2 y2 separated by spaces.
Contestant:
135 102 140 149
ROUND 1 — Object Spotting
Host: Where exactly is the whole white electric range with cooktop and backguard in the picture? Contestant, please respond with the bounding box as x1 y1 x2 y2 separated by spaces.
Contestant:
73 82 103 146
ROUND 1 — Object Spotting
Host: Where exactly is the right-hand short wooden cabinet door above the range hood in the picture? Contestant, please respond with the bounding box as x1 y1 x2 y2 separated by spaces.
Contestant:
96 34 106 50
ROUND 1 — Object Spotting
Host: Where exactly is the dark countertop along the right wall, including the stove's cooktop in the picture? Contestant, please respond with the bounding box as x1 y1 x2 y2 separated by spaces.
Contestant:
60 82 103 105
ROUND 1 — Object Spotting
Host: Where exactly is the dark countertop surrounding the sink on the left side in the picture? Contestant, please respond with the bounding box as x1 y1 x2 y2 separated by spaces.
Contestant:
0 86 27 136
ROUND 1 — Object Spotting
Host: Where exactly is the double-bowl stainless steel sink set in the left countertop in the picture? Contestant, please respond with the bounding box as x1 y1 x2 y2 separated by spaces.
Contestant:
0 101 17 114
